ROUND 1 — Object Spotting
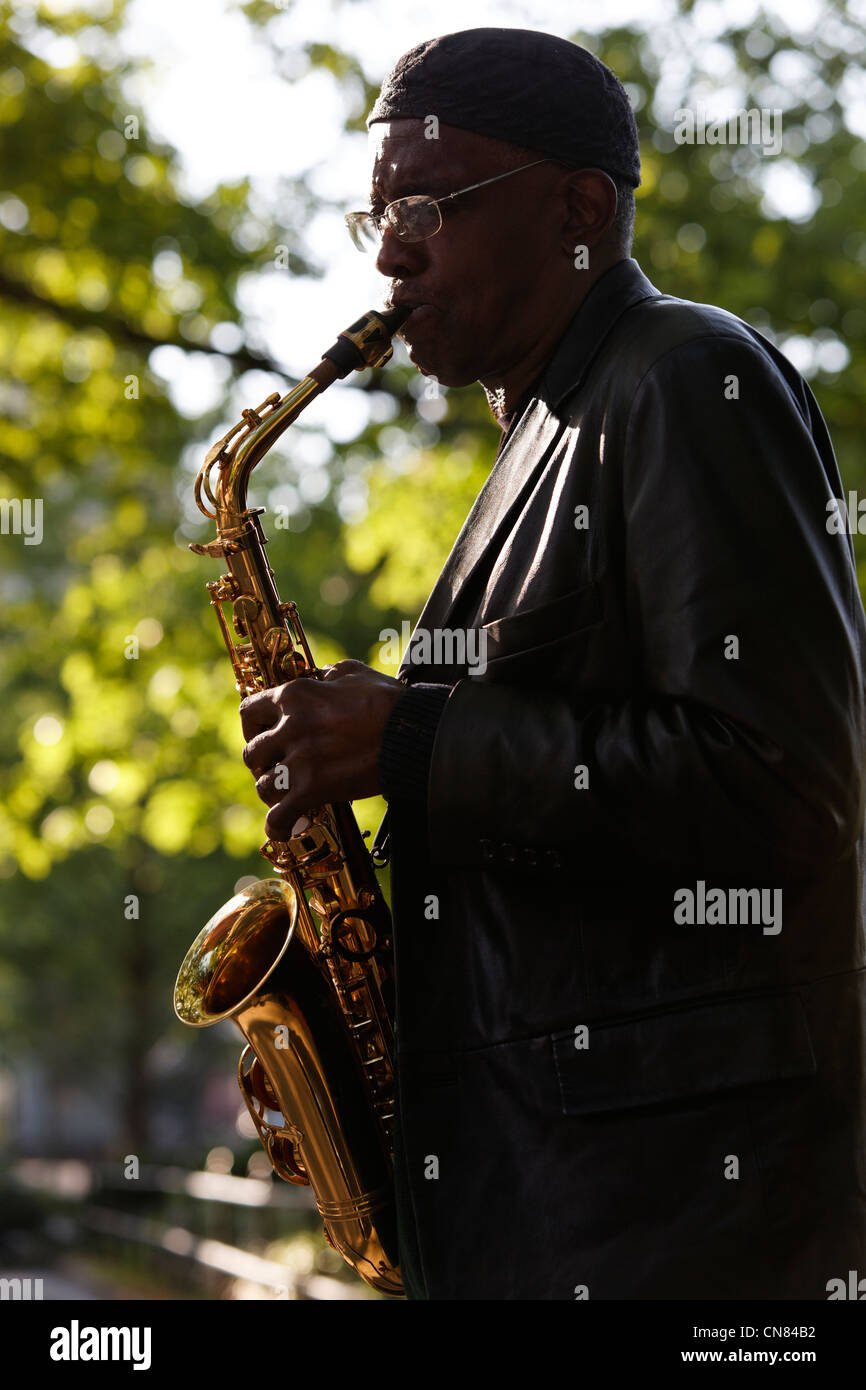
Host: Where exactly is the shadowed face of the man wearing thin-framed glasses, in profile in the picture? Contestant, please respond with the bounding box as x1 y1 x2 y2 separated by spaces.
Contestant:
370 120 564 386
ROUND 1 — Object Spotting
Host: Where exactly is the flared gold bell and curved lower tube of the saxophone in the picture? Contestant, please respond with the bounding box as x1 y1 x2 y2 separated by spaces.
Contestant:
175 878 403 1294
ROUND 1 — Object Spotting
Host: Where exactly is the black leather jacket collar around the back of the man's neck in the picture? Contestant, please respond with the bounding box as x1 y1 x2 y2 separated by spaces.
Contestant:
531 257 662 410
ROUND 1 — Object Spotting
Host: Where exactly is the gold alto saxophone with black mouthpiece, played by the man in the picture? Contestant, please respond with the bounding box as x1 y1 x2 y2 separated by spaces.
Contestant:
174 309 409 1295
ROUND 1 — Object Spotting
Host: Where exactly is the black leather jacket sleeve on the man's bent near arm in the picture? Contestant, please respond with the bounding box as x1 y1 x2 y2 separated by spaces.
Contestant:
428 334 865 874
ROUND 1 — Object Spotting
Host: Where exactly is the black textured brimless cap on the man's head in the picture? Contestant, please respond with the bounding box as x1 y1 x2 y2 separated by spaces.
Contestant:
367 29 641 188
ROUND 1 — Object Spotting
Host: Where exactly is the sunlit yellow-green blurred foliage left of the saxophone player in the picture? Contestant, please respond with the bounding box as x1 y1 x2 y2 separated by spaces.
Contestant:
0 3 366 1137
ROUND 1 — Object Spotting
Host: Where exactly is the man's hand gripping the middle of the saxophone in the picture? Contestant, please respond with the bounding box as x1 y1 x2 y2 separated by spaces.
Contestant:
240 660 406 840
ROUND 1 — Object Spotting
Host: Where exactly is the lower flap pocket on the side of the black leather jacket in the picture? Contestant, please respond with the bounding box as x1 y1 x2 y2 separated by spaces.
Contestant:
550 994 817 1115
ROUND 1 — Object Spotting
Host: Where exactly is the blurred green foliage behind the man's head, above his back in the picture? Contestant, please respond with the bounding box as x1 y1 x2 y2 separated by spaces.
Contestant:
592 3 866 500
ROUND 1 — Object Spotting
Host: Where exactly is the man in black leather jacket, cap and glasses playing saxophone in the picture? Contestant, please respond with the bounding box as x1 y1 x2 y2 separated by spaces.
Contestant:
242 29 866 1300
